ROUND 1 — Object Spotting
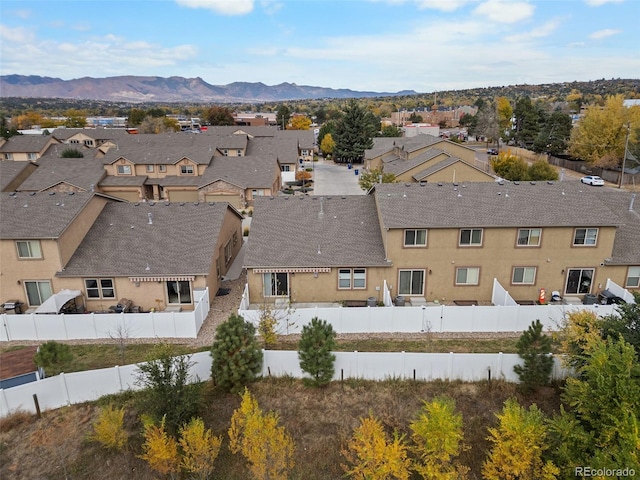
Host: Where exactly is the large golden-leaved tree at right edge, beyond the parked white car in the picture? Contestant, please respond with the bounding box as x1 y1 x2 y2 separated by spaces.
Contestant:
569 95 640 167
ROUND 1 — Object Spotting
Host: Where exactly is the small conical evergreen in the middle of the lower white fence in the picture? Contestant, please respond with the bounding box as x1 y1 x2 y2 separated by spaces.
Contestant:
298 317 336 387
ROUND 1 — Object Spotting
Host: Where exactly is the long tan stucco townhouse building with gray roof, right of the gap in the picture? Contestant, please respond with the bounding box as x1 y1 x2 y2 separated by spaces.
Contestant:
245 182 640 304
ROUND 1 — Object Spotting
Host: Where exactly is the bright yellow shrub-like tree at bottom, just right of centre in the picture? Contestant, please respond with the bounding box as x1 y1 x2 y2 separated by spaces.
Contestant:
342 413 411 480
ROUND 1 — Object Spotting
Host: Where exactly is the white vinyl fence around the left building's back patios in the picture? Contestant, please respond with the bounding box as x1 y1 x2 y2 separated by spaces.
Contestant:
0 288 210 342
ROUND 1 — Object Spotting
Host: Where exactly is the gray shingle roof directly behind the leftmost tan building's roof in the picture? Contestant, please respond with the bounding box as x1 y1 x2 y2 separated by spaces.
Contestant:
18 152 107 192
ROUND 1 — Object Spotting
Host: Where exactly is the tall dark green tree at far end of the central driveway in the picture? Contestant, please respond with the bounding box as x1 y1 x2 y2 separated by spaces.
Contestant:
333 100 380 163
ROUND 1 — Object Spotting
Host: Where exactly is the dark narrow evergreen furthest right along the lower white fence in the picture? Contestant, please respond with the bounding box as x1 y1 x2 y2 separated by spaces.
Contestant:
513 320 553 393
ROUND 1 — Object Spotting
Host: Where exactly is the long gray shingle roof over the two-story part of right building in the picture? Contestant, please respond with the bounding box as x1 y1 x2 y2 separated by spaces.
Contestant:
375 182 622 228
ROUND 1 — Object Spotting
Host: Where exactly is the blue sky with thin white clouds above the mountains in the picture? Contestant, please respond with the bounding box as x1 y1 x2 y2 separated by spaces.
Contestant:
0 0 640 92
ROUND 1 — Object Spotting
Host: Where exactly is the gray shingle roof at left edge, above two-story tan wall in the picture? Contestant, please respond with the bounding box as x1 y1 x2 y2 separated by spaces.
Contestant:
0 192 102 240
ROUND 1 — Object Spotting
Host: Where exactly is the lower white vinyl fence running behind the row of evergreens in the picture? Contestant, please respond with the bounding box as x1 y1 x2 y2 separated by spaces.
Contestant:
0 350 567 417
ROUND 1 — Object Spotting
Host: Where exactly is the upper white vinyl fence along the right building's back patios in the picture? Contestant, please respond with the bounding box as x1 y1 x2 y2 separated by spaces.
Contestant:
238 304 615 335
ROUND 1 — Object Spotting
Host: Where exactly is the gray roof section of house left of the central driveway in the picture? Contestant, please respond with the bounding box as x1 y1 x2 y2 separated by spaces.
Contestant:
200 155 278 188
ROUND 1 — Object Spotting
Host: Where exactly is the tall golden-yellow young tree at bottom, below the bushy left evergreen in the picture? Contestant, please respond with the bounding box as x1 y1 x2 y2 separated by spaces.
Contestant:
229 388 295 480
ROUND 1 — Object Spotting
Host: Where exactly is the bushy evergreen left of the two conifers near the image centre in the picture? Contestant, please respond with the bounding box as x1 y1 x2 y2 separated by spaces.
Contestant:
211 314 262 393
